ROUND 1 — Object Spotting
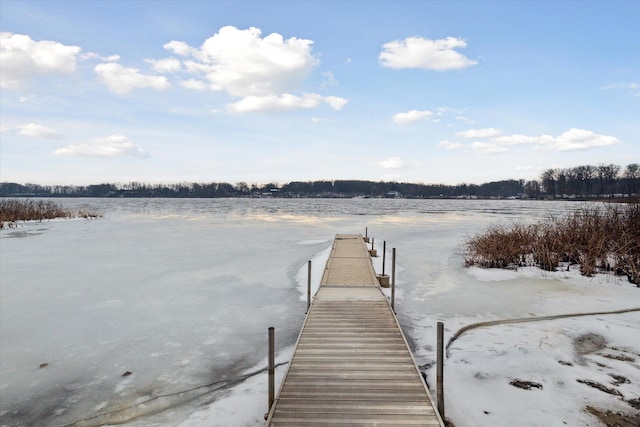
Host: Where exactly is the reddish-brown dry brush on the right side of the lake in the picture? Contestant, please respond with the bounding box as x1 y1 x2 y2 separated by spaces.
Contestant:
463 203 640 286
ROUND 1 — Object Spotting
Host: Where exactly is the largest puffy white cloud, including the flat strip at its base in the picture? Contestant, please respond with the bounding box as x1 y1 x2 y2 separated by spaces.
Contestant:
159 26 347 113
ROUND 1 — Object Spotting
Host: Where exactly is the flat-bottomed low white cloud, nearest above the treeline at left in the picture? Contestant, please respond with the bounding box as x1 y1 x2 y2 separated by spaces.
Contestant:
54 134 150 158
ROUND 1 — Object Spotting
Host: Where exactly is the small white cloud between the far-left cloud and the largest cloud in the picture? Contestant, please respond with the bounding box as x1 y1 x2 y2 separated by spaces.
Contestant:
94 62 169 95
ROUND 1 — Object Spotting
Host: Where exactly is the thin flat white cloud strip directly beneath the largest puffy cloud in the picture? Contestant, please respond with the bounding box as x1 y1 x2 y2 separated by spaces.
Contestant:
227 93 347 113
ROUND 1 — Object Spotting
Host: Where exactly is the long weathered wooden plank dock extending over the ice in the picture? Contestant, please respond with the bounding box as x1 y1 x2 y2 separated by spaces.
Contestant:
266 234 444 426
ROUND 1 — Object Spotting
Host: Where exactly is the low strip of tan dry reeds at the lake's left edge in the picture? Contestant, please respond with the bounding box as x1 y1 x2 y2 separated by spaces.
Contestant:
0 199 102 229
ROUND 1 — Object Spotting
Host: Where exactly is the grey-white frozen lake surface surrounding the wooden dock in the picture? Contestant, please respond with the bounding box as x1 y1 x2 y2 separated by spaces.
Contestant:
0 199 640 427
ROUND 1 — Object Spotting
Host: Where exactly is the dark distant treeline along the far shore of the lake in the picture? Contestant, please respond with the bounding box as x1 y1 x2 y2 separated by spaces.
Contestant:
0 163 640 198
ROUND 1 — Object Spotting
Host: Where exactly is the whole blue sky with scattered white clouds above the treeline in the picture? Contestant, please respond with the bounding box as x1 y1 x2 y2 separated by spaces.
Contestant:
0 0 640 185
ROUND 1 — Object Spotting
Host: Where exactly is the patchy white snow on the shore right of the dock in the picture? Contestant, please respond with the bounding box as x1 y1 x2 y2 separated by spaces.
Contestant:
445 279 640 426
